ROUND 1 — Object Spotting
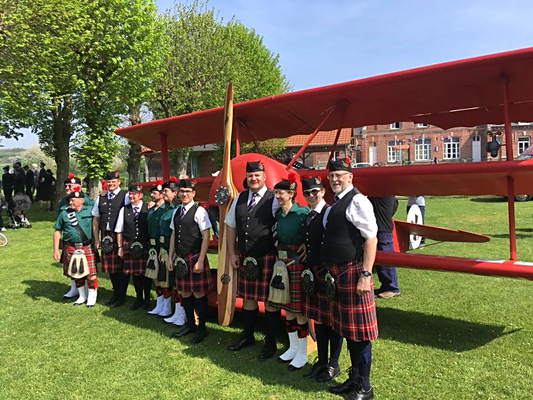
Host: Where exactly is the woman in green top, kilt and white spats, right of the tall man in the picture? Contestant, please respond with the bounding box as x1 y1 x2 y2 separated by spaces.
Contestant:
270 175 309 371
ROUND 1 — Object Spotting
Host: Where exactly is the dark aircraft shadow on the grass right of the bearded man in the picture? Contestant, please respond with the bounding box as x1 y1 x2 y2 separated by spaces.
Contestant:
377 307 516 352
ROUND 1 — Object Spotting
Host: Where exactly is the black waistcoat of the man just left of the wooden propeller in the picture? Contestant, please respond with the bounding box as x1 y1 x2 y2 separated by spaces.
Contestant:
174 204 202 254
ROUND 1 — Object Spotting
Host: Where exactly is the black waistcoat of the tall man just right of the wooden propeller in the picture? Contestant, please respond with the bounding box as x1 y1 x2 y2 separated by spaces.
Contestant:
235 190 276 258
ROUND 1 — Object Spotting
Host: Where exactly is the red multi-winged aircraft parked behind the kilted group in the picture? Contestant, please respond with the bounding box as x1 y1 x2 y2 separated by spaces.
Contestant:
116 48 533 324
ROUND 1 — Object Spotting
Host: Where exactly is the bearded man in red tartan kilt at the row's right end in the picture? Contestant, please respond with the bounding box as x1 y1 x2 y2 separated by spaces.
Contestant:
320 158 378 400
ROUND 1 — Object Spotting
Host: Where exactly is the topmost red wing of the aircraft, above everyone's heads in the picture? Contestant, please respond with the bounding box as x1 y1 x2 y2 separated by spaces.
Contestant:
116 48 533 150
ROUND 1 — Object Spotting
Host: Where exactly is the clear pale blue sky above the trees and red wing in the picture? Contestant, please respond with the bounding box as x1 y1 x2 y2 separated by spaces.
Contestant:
5 0 533 147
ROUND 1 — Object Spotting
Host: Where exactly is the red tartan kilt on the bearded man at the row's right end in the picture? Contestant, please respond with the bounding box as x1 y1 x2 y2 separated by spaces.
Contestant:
327 261 378 341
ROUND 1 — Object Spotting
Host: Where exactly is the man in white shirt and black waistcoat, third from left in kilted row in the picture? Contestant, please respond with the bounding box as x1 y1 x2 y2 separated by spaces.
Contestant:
115 183 150 310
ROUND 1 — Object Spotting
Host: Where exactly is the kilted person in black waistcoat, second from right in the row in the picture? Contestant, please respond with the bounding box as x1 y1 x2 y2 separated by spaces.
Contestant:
302 176 342 382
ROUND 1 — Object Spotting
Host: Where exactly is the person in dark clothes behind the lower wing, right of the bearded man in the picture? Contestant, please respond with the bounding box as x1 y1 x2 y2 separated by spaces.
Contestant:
368 196 400 299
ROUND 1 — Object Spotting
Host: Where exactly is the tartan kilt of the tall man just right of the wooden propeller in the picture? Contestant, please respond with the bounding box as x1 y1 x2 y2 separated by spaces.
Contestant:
237 252 276 301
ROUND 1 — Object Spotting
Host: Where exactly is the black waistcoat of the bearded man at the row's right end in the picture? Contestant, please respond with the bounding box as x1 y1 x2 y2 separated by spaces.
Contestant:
320 189 365 265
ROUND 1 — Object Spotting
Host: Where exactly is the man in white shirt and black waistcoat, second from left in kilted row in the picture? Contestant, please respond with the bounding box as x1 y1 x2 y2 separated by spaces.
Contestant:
92 171 130 305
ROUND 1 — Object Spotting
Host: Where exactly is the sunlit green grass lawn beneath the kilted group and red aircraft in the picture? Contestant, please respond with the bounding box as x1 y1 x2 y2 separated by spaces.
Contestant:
0 197 533 400
